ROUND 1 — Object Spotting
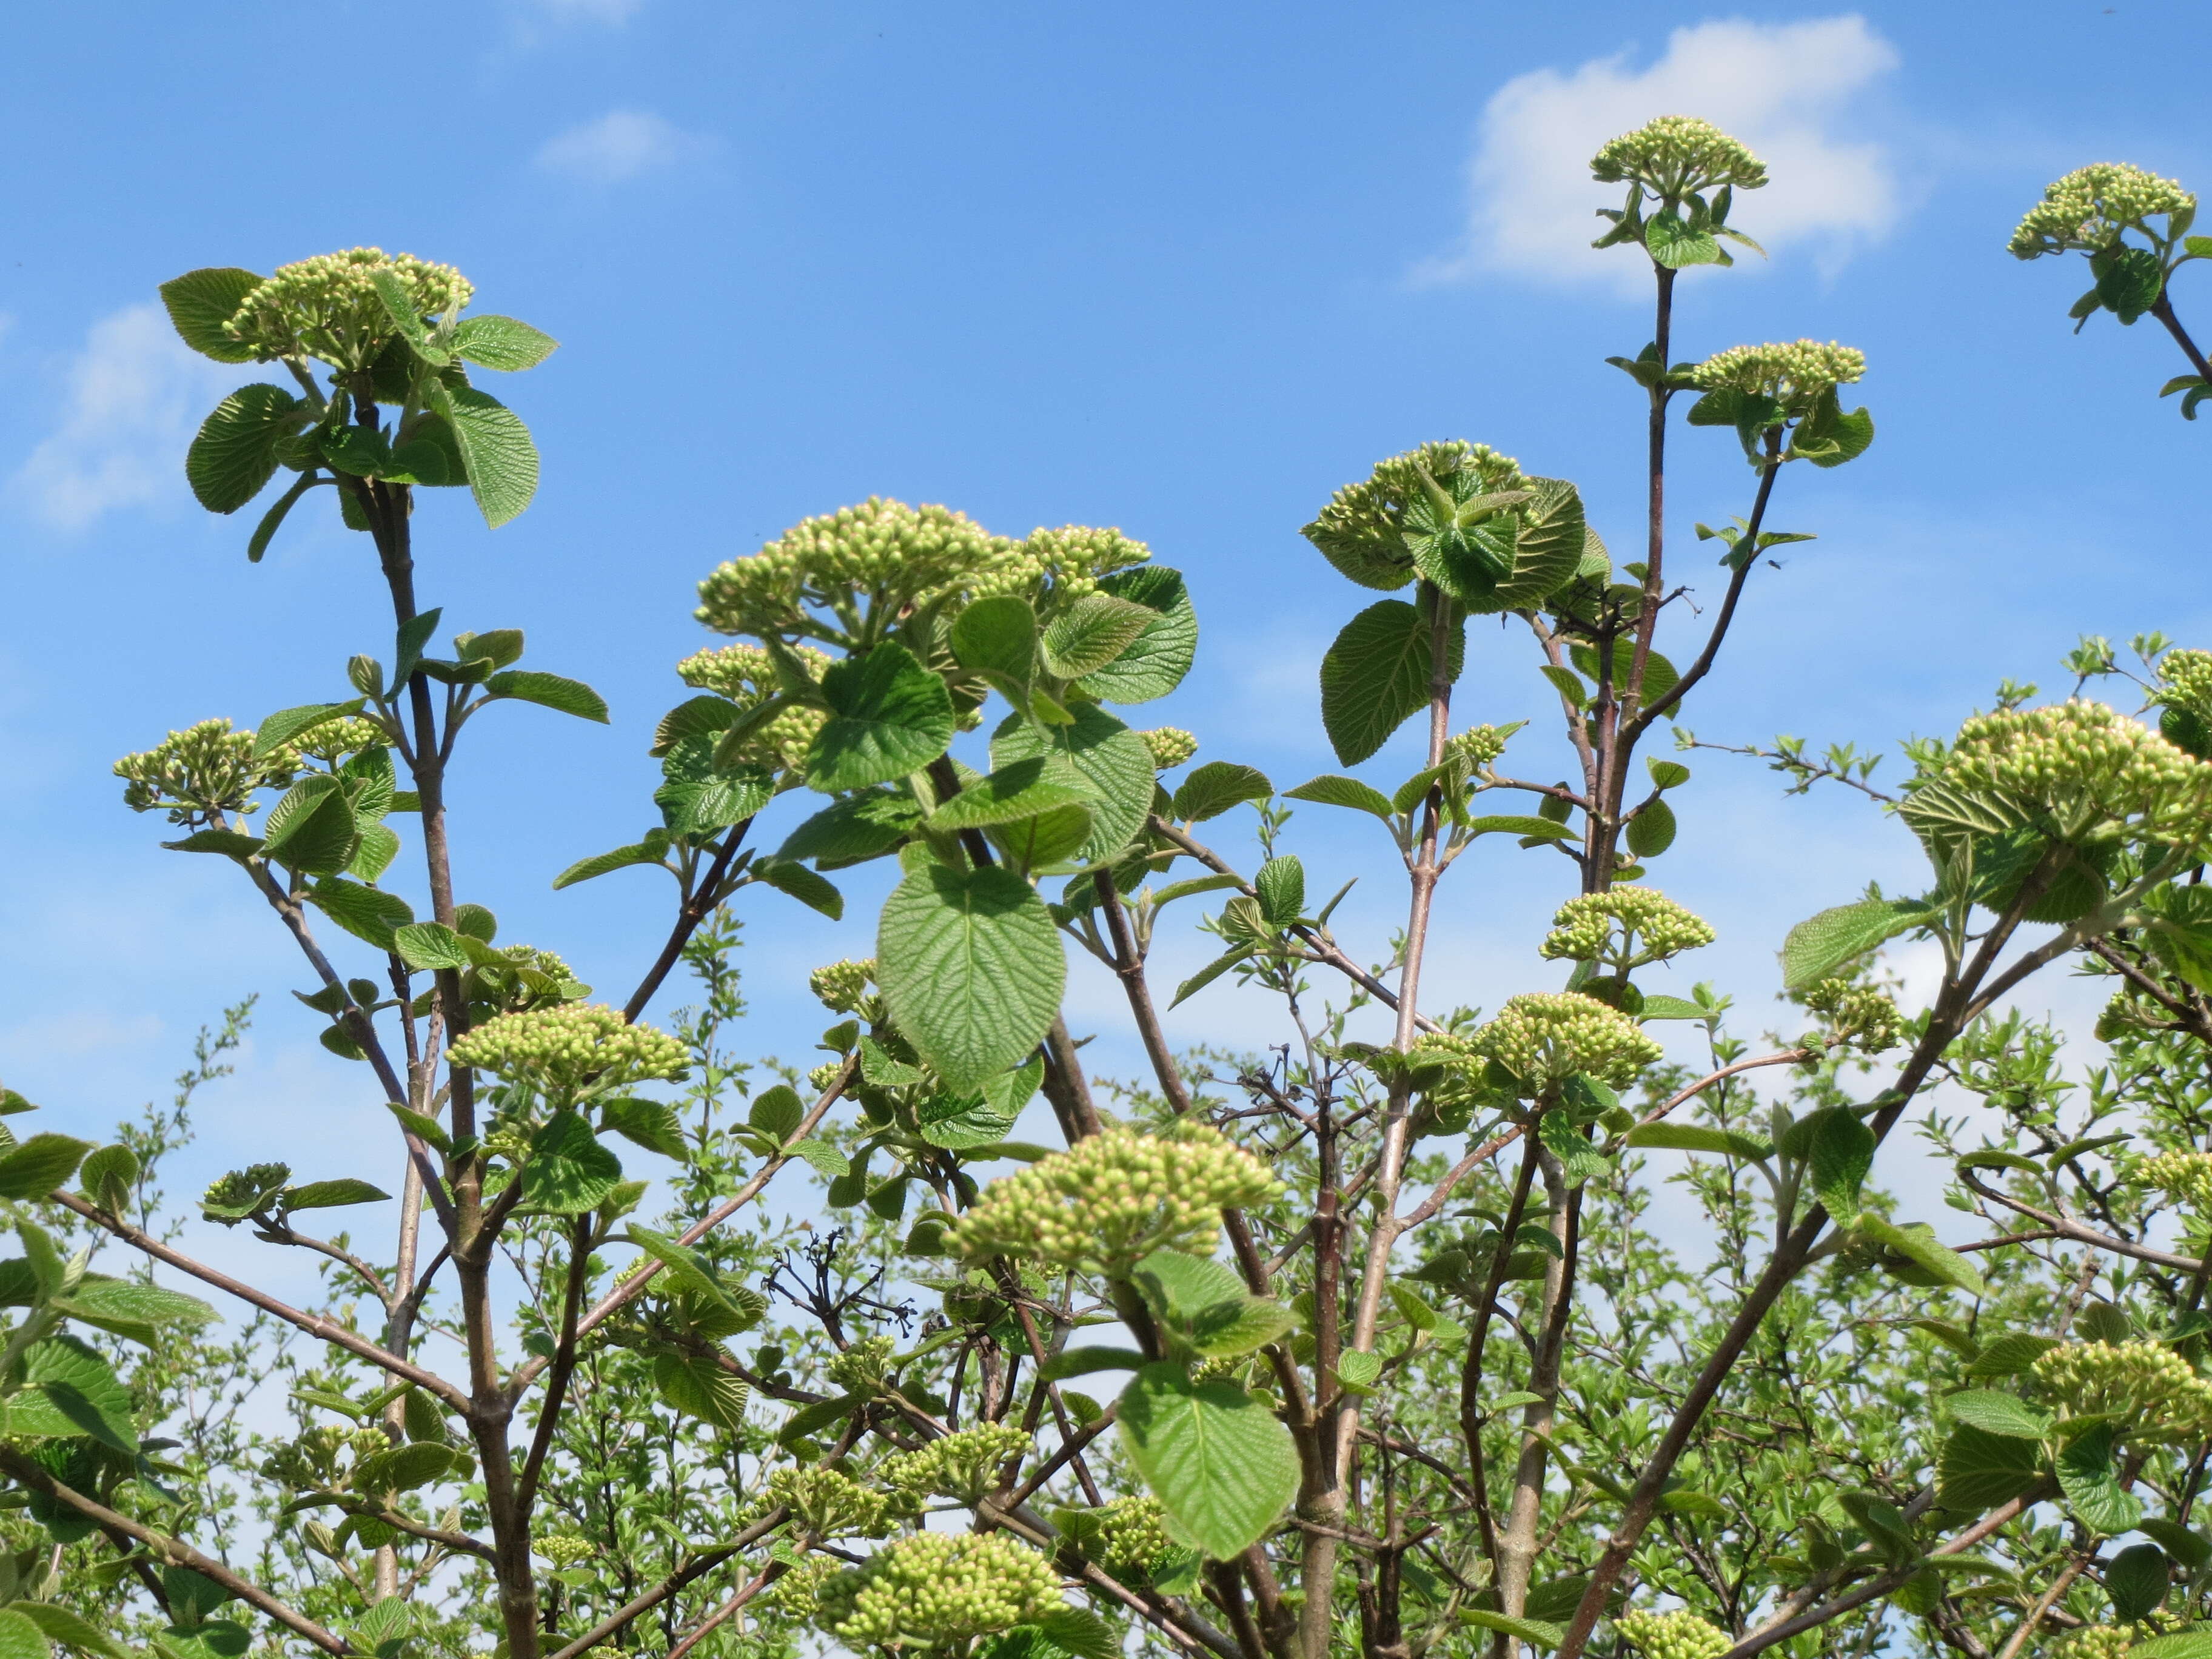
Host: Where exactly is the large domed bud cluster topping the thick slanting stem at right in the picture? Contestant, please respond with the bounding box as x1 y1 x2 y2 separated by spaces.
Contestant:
1936 699 2212 845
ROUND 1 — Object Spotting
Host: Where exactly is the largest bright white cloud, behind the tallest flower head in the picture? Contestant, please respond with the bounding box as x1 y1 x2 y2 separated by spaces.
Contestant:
1418 16 1900 286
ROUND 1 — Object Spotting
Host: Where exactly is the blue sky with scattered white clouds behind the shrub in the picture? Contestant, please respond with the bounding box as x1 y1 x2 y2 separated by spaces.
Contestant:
0 0 2212 1274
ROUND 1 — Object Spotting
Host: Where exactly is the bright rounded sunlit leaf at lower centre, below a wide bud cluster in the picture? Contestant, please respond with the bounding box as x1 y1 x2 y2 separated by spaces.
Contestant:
1119 1365 1298 1561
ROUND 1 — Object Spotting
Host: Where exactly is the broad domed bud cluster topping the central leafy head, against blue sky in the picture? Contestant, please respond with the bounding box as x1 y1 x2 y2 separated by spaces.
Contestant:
694 495 1027 632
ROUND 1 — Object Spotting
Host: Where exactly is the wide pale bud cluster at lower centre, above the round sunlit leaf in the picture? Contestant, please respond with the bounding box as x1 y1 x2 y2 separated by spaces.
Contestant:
949 1124 1281 1272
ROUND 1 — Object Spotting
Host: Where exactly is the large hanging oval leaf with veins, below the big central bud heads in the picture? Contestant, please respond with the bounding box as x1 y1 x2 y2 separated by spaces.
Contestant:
876 865 1066 1093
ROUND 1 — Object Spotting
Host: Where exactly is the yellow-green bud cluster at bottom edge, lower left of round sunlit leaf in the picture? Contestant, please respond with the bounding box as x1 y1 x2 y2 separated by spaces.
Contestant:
816 1533 1059 1650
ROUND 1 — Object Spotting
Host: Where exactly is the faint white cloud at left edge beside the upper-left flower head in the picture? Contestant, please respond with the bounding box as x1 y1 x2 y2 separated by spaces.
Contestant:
9 305 239 531
